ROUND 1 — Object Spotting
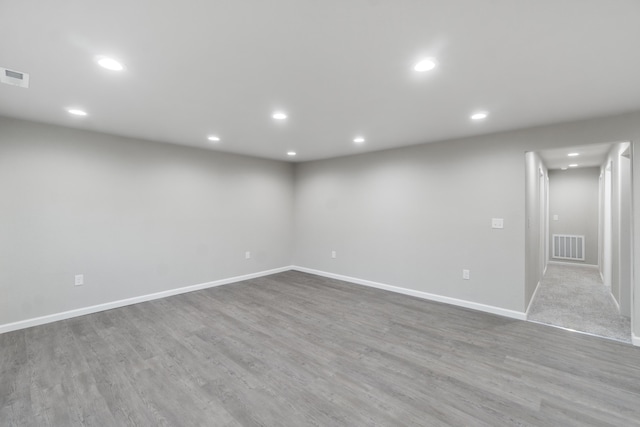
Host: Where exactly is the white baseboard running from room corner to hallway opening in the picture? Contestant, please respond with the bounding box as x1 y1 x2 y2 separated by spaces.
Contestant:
292 265 527 320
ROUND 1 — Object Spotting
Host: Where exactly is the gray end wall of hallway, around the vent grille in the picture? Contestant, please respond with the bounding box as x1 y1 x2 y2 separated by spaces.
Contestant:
549 167 600 265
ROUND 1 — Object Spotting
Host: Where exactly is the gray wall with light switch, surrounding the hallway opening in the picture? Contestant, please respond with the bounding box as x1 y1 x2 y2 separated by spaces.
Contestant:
294 112 640 331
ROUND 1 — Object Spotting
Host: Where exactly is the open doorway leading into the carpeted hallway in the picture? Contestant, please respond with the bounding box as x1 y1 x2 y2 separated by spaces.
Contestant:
525 142 633 342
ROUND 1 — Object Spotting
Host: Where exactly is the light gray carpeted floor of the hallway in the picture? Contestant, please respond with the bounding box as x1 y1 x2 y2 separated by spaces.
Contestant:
527 263 631 343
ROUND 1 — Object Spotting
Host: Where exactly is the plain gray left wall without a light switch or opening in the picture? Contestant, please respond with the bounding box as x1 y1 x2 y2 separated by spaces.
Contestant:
0 118 293 325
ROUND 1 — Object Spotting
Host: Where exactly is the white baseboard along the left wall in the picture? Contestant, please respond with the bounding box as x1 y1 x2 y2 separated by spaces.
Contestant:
0 266 293 334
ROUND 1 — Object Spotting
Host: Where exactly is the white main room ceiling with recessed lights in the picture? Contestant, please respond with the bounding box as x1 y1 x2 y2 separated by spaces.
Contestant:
0 0 640 161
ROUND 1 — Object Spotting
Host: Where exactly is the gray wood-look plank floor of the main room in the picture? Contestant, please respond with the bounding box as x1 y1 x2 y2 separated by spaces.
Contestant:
0 271 640 427
